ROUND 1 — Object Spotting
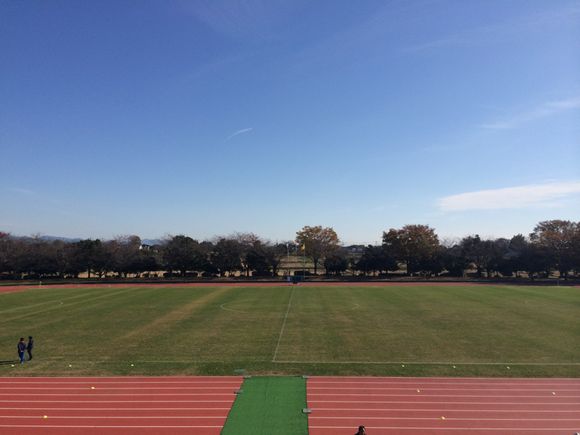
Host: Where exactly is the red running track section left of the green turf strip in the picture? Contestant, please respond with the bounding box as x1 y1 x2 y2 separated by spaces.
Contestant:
0 376 243 435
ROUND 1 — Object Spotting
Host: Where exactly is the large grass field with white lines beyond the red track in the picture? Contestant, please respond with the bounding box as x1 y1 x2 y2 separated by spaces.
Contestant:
0 285 580 377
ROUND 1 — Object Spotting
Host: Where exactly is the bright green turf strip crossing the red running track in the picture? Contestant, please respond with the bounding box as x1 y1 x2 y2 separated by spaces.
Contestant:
222 376 308 435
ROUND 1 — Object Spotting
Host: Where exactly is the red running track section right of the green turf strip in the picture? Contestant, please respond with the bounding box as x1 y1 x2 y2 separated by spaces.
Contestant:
307 377 580 435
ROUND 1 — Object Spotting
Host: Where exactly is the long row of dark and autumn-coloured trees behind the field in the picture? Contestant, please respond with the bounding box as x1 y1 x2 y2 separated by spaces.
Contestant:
0 220 580 278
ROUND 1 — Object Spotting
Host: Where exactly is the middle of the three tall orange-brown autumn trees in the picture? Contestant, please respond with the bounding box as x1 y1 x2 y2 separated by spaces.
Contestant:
383 225 439 274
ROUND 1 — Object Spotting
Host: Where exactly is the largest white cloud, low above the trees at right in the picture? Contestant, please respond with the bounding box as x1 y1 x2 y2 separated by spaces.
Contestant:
437 181 580 212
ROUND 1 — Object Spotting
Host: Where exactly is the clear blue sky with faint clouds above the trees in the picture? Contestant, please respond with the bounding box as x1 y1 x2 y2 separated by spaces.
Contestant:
0 0 580 243
